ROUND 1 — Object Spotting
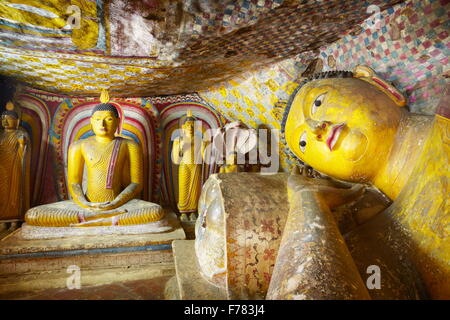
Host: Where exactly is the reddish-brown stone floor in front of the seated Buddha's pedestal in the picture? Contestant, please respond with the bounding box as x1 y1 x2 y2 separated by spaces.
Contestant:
0 276 172 300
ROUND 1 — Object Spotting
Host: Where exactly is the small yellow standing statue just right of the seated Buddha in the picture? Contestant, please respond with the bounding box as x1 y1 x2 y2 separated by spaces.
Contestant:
172 110 205 220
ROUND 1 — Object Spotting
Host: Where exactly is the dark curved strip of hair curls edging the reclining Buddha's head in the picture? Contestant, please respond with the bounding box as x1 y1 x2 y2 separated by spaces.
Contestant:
281 70 353 165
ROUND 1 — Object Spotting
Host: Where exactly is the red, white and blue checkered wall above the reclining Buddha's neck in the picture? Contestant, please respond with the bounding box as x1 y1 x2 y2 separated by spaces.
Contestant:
320 0 450 114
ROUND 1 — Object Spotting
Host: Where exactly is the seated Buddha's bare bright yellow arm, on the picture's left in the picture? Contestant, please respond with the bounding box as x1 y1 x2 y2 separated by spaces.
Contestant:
67 143 89 208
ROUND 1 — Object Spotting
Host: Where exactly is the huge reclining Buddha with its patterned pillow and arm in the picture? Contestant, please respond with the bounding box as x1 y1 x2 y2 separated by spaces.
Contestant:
195 66 450 299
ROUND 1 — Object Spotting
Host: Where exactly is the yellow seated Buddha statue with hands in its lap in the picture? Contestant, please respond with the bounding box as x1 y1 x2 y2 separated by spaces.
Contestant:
25 92 164 227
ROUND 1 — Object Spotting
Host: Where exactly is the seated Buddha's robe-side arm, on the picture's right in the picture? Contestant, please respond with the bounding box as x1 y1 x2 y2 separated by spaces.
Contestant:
99 141 144 210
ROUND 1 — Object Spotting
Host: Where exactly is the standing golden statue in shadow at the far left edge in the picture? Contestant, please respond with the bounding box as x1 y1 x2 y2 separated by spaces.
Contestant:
0 102 31 222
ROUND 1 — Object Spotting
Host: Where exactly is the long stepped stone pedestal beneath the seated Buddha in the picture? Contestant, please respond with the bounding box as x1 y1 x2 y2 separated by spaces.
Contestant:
0 213 186 297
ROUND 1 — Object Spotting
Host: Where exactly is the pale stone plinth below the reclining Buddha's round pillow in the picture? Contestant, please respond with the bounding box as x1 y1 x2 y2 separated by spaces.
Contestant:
166 240 227 300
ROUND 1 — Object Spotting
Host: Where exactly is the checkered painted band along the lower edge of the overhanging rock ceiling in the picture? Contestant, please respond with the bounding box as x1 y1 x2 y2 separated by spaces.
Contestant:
0 0 398 96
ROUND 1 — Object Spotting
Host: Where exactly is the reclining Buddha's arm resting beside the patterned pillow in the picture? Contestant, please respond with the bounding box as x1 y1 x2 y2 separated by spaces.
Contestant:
266 175 370 300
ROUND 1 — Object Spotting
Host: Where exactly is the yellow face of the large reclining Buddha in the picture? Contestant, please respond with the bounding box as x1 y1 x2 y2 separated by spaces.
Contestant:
285 78 402 182
